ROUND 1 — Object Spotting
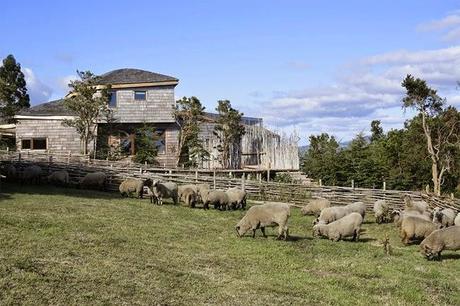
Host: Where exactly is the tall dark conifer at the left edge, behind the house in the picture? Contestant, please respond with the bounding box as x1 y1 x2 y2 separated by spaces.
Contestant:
0 54 30 123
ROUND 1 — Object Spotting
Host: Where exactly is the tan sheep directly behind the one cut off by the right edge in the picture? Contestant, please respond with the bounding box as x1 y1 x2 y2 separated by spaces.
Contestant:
400 216 439 245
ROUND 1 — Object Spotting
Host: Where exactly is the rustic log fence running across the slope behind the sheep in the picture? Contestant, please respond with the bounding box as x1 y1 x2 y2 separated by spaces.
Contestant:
0 152 460 211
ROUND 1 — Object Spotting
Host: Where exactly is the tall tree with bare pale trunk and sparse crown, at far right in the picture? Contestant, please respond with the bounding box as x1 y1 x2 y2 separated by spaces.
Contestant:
402 75 460 196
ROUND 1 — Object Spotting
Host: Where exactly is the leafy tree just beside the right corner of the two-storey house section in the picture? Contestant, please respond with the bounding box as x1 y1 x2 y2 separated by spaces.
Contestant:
174 97 209 167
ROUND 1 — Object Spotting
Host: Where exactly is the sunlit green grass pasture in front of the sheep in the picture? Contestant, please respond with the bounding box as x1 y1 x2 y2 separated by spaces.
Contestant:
0 185 460 305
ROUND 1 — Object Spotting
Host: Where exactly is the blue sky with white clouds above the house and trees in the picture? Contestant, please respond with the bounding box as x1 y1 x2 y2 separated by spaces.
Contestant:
0 0 460 144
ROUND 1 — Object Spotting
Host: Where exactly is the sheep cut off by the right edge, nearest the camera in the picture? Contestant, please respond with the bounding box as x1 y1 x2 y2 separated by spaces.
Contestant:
420 226 460 260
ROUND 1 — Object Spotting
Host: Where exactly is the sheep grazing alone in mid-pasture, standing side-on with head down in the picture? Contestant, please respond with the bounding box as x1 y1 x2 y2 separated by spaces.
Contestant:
235 203 291 240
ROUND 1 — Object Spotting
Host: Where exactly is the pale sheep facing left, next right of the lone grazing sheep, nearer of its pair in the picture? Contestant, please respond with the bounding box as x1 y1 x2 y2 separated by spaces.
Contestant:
313 212 363 241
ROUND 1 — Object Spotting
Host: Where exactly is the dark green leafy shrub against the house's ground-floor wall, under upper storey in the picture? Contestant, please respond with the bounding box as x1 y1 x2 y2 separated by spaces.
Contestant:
133 124 159 164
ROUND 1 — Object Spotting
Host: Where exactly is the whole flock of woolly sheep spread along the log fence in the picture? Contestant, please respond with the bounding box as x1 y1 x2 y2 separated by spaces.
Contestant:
3 164 460 259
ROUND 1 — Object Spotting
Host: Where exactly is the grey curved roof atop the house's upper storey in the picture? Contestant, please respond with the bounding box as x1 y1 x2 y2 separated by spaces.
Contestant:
98 68 179 84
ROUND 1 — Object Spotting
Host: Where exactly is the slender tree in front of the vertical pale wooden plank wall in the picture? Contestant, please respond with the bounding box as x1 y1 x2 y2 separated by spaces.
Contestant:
214 100 245 169
